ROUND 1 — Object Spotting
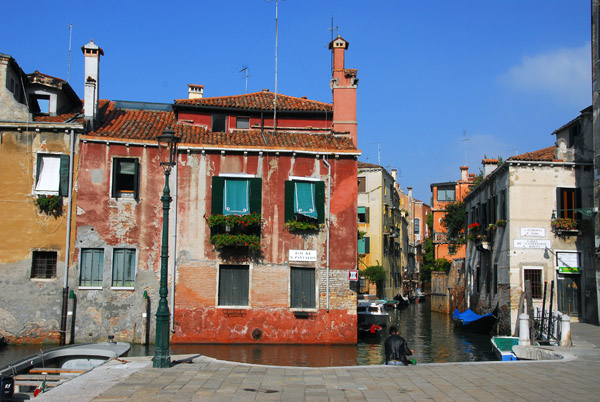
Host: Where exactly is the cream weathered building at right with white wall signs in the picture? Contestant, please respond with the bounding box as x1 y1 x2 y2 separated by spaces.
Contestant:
465 108 597 334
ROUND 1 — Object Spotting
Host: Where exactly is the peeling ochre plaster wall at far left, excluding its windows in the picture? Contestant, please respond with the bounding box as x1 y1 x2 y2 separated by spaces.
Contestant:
0 128 77 343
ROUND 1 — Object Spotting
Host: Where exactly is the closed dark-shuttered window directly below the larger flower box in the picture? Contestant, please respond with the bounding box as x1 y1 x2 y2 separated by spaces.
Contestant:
219 265 250 306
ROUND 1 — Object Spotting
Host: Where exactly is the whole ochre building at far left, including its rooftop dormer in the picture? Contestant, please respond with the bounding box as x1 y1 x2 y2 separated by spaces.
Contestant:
0 54 85 343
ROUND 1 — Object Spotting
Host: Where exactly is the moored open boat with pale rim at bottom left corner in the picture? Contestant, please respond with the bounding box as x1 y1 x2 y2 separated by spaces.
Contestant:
0 342 131 400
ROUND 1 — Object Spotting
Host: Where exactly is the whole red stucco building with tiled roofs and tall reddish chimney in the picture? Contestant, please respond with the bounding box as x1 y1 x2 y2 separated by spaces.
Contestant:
72 37 360 344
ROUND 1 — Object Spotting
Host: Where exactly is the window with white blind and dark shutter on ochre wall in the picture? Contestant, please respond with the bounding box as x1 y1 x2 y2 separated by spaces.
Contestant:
35 154 69 197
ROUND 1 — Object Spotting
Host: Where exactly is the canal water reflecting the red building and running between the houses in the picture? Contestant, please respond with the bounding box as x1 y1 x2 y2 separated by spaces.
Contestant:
0 302 496 367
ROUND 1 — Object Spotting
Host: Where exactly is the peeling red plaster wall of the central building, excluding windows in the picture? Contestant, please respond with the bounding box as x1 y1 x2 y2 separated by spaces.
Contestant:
73 142 357 343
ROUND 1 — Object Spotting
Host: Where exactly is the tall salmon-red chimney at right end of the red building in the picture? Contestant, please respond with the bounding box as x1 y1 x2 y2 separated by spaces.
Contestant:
329 35 358 146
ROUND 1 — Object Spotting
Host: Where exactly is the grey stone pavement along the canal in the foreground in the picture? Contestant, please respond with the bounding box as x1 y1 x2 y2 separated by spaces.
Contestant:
36 323 600 402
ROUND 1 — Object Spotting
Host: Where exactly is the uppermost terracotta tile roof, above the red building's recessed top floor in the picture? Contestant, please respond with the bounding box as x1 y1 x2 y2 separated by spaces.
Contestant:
175 92 333 112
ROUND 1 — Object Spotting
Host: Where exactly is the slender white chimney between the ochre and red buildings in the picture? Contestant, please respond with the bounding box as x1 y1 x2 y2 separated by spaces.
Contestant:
81 39 104 128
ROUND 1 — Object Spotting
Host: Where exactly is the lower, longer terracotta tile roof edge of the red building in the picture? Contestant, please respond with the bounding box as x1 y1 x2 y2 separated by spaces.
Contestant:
89 102 356 151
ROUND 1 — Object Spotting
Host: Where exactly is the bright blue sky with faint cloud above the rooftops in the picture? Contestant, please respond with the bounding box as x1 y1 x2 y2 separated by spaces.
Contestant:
0 0 592 203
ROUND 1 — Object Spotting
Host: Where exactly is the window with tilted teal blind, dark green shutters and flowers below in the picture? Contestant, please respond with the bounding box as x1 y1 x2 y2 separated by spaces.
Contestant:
285 178 325 233
